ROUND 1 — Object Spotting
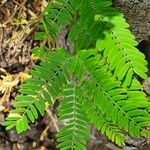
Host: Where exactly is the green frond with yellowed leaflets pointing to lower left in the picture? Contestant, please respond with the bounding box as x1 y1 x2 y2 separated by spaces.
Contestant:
4 49 68 133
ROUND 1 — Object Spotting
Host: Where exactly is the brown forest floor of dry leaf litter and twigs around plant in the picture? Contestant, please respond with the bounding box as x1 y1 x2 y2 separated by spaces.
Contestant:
0 0 150 150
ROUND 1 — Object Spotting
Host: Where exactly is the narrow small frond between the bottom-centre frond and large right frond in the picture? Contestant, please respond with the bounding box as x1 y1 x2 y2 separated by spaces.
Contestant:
81 84 125 146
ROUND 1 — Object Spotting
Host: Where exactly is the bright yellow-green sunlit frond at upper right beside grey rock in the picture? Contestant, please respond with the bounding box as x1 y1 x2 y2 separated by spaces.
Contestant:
96 7 147 82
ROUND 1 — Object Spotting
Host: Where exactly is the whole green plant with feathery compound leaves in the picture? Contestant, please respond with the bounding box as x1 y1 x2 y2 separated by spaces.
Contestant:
3 0 150 150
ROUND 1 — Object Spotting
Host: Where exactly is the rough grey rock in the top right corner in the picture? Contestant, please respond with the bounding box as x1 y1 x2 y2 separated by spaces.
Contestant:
113 0 150 42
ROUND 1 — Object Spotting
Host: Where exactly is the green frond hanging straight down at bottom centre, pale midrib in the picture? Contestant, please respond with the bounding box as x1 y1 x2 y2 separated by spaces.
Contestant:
57 83 89 150
